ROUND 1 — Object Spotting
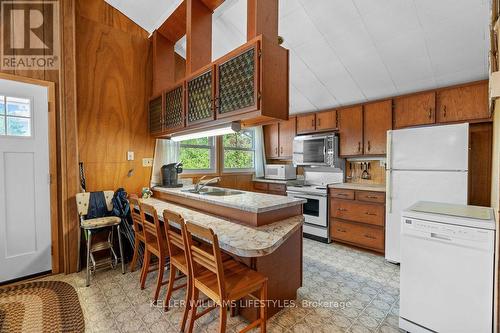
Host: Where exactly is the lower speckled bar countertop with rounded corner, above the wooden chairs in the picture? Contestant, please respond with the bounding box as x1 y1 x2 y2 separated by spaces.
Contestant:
141 198 304 257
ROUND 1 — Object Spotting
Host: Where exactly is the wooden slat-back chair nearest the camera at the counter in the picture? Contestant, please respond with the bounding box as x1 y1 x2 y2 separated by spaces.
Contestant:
185 222 267 333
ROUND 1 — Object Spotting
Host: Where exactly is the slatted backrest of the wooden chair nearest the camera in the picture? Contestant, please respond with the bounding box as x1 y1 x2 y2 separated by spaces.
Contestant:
186 222 226 299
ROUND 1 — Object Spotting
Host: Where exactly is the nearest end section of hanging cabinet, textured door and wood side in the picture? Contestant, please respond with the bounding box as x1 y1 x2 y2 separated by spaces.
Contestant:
214 36 289 126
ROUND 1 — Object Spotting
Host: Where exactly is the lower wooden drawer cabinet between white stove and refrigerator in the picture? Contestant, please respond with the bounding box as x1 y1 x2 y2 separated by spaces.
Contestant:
330 189 385 253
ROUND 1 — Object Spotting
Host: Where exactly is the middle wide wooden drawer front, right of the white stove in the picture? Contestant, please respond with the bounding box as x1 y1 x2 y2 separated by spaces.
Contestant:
330 199 385 226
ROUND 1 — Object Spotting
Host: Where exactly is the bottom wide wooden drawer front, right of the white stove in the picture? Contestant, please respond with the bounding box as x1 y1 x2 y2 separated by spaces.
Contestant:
330 219 384 251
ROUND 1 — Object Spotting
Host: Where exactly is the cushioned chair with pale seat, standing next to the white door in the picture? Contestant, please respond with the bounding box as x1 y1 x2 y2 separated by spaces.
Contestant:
76 191 125 286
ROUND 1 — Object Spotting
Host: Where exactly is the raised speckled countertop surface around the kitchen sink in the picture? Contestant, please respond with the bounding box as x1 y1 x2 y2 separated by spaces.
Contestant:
153 186 306 214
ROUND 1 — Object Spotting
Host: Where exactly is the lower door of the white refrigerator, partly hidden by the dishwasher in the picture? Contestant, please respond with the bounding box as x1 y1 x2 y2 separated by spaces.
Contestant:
385 171 468 263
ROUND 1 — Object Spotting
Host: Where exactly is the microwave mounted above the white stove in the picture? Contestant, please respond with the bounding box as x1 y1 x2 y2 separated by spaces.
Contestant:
293 133 342 168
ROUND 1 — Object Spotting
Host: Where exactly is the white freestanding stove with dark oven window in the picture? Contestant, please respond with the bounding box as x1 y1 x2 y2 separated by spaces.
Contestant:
286 167 344 243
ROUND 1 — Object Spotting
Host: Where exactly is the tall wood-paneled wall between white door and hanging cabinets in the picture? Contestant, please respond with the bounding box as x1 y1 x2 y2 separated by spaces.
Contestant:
76 0 154 193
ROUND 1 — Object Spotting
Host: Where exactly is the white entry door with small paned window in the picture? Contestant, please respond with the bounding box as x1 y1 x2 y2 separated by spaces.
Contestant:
0 79 52 282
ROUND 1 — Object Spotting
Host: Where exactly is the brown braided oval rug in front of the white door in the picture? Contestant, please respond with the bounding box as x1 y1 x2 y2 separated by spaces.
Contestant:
0 281 85 332
